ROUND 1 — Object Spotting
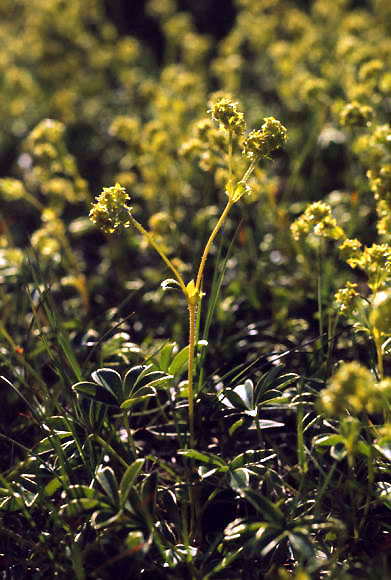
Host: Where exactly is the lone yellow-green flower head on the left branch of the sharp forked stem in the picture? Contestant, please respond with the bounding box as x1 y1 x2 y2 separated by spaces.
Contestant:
90 183 132 234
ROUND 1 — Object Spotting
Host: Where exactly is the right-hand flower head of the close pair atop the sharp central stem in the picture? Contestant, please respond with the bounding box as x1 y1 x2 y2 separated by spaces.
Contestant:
243 117 288 159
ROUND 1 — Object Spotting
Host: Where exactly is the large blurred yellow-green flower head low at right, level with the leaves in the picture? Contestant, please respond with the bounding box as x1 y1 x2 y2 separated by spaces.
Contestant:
319 362 391 417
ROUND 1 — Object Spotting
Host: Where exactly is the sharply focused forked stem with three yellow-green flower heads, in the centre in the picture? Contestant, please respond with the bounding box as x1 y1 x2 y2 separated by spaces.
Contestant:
90 97 287 533
